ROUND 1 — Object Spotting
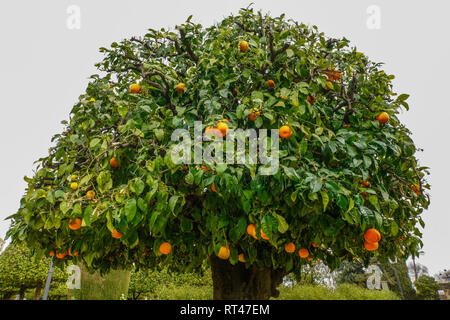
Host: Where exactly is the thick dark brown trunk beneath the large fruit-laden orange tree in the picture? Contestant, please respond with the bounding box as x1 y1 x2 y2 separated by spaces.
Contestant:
210 256 286 300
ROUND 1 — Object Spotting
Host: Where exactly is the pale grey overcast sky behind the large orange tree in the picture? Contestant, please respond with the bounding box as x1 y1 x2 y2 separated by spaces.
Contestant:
0 0 450 274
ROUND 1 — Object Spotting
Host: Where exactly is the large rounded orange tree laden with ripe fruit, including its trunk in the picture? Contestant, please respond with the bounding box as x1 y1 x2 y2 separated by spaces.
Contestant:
8 8 429 299
